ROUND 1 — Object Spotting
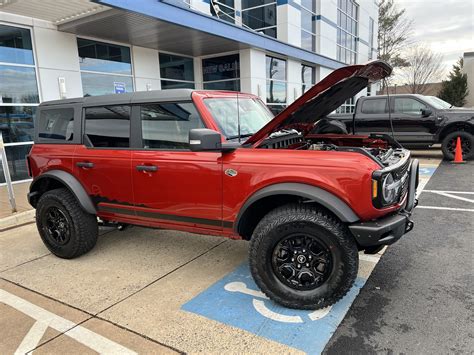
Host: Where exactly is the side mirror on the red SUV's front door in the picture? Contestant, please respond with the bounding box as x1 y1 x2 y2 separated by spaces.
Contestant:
189 128 241 153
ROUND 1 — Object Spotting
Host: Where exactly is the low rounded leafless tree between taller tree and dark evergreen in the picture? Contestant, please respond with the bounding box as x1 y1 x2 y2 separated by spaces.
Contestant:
400 44 443 94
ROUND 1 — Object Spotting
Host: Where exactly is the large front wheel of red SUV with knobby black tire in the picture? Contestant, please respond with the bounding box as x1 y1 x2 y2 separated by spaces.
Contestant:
249 204 359 309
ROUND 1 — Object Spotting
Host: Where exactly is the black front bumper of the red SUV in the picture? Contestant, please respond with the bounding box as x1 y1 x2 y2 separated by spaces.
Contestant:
349 159 419 247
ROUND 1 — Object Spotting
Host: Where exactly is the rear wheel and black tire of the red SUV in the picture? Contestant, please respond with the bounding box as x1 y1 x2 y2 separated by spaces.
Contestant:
36 189 98 259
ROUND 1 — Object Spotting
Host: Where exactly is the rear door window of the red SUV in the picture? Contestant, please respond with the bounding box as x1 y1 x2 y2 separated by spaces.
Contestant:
85 105 130 148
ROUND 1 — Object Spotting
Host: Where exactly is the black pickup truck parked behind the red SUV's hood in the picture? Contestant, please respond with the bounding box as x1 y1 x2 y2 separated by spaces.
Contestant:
329 94 474 160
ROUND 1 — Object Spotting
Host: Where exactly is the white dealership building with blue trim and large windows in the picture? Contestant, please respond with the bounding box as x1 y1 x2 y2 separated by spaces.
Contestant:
0 0 378 184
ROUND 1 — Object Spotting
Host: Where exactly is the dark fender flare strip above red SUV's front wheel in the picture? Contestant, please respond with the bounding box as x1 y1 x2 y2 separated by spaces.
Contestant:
234 183 359 231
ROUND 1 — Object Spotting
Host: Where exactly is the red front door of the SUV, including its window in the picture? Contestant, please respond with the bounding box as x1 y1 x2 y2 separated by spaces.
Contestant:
132 102 222 232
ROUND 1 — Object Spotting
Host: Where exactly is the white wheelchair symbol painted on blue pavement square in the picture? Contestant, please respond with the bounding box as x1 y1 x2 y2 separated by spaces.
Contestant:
224 282 332 323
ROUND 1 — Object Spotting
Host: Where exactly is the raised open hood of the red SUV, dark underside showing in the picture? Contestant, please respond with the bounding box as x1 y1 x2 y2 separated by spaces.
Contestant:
244 60 392 144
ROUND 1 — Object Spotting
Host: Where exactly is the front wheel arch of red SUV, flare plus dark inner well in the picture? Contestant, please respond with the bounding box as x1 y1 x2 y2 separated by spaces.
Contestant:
234 183 359 240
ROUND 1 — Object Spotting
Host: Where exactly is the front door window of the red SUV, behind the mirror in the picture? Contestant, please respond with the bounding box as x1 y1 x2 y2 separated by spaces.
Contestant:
140 102 204 150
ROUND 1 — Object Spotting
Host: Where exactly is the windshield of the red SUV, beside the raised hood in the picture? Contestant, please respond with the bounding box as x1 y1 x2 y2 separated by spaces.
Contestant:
204 97 273 139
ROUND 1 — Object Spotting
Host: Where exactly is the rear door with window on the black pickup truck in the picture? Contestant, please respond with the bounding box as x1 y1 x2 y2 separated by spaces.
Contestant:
355 97 390 134
